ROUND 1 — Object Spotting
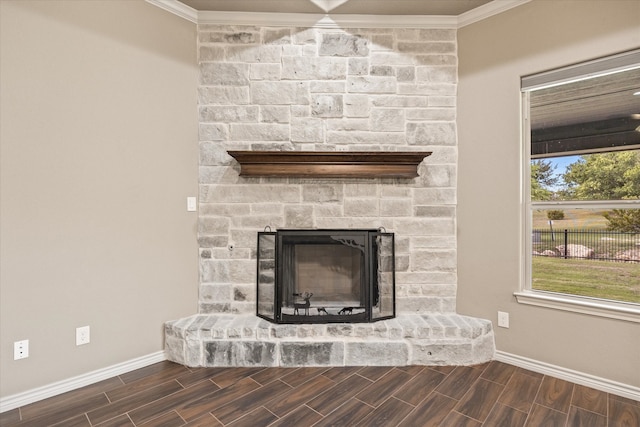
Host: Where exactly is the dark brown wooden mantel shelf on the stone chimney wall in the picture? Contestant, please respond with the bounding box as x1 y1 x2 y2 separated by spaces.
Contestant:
228 151 431 178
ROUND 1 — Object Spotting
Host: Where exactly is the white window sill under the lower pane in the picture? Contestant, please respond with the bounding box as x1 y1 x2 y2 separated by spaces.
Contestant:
514 291 640 323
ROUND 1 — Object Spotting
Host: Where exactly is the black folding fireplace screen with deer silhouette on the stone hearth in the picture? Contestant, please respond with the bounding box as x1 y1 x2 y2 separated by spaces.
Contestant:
257 230 395 323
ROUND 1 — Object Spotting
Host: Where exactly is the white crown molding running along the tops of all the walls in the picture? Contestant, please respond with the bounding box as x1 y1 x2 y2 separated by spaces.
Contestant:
146 0 531 29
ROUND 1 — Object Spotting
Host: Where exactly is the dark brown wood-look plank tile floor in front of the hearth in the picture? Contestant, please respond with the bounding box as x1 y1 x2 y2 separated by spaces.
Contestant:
0 361 640 427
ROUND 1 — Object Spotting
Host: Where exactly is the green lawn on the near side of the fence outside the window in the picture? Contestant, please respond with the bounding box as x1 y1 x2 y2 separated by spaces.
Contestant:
532 256 640 303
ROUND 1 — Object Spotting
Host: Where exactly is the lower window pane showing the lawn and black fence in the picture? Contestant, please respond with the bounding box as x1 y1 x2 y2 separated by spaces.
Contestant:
531 209 640 303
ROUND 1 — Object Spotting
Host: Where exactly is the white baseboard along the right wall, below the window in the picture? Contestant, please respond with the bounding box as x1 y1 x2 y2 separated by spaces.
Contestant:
495 351 640 401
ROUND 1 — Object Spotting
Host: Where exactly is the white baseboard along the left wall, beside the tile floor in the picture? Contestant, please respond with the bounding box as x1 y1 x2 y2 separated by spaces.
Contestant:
0 351 167 413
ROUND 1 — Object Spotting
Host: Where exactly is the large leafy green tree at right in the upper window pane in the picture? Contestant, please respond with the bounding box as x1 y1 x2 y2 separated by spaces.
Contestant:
563 150 640 200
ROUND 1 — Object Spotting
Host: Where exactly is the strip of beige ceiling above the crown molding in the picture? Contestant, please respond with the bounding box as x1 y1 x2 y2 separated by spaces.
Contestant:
181 0 493 16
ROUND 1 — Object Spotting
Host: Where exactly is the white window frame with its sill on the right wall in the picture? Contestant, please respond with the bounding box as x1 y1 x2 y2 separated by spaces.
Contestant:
514 50 640 323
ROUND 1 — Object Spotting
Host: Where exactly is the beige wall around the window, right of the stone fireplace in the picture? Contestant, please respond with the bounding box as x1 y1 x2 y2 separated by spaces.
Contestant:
458 0 640 387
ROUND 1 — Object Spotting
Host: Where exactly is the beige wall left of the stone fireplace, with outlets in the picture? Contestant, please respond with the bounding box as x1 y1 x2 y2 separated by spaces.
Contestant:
0 0 198 397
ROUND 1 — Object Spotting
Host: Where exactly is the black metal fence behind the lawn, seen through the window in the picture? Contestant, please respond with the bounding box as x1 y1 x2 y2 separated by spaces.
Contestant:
532 229 640 262
